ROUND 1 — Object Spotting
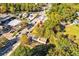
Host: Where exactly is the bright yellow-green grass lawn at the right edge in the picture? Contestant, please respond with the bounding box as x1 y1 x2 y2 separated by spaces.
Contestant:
64 25 79 43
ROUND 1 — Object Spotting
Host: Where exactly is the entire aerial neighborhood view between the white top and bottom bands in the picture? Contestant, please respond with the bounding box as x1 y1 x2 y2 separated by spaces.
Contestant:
0 3 79 56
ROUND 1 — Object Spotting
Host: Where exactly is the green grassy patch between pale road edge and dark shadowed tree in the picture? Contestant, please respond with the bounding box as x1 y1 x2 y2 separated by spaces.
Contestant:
11 45 30 56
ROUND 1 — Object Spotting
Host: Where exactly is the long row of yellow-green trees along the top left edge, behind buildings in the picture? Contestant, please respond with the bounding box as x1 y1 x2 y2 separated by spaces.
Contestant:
0 3 42 13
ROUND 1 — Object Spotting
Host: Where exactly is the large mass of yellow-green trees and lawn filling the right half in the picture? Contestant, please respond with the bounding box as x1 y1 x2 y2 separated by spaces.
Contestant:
31 4 79 56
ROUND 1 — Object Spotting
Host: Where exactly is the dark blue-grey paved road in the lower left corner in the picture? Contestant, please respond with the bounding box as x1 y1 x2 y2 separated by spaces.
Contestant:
0 38 19 56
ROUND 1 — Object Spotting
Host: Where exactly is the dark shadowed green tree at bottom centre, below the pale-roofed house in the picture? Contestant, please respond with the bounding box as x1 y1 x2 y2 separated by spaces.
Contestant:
30 44 55 56
